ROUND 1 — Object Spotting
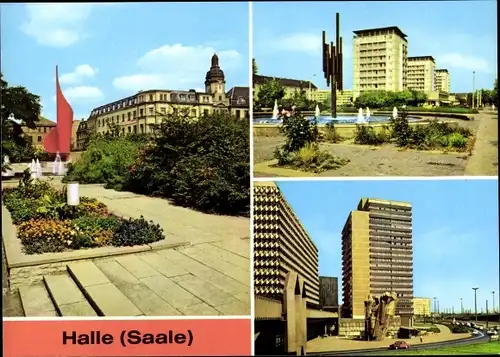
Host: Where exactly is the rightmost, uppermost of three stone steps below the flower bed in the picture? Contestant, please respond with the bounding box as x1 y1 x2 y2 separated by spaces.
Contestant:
67 261 143 316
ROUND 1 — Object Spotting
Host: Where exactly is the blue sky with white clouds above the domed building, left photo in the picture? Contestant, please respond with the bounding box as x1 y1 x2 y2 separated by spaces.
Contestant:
1 3 249 121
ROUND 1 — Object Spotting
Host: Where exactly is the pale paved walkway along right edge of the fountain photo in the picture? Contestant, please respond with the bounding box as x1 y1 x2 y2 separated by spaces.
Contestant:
465 111 498 176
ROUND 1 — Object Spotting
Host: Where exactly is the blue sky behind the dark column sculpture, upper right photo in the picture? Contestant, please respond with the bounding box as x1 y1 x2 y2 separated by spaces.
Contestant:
253 0 497 92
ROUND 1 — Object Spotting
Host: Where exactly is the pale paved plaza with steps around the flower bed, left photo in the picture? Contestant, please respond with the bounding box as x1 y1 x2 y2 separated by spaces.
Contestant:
4 185 251 316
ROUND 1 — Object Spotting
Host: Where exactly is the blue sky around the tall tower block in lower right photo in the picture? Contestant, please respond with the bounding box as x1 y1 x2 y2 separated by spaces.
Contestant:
278 180 500 311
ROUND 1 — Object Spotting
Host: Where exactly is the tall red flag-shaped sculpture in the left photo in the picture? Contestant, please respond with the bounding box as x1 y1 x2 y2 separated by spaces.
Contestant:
43 66 73 160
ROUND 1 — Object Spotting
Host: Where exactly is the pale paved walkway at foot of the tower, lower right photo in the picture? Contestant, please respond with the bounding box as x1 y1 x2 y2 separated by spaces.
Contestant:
307 324 470 353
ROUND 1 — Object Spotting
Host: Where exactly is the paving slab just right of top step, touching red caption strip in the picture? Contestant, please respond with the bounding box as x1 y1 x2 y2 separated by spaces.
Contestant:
116 283 182 316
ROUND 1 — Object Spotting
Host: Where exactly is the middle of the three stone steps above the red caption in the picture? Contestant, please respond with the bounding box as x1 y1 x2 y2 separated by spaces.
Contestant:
43 274 97 316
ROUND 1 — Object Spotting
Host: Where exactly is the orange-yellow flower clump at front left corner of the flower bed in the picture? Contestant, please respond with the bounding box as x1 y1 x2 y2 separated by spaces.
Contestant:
17 219 77 254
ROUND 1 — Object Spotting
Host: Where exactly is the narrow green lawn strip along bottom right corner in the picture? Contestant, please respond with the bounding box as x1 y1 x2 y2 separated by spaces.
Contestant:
374 342 500 356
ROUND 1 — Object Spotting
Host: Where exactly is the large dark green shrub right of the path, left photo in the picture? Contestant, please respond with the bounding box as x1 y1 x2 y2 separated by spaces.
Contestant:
123 113 250 215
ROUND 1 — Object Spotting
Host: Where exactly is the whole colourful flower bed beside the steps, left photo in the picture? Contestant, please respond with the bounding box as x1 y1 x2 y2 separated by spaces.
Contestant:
2 175 165 254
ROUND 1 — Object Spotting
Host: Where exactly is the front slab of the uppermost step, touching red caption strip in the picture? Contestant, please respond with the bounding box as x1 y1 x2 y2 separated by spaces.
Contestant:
85 283 143 316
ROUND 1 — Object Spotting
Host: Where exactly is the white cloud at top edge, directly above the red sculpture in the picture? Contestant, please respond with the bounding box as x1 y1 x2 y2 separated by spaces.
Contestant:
21 3 117 47
